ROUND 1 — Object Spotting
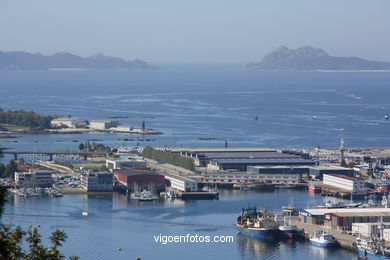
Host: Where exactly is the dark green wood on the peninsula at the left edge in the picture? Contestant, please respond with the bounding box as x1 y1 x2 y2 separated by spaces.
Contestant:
0 108 54 129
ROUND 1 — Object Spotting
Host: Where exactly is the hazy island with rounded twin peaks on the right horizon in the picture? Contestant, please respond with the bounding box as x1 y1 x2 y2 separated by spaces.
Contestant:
243 46 390 71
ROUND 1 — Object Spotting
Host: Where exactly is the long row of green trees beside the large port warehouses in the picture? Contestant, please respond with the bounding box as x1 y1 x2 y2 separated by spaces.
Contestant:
142 146 195 170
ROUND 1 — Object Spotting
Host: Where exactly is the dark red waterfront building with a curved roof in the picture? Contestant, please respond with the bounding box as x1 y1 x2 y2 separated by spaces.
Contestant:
113 168 165 191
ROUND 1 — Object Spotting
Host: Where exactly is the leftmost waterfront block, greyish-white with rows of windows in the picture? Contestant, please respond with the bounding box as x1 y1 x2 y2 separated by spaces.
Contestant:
15 171 53 188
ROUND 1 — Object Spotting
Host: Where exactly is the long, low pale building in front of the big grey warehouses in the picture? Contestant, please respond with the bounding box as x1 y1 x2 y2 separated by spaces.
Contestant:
199 173 301 184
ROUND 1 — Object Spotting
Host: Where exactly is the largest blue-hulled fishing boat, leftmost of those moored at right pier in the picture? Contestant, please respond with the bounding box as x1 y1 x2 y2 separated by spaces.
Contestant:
236 207 279 238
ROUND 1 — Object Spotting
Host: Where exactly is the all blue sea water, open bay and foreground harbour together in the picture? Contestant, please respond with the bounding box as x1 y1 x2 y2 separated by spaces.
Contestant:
0 64 390 260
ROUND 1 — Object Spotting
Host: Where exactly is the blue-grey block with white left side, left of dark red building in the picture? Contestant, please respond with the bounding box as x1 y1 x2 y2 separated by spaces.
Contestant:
81 172 113 191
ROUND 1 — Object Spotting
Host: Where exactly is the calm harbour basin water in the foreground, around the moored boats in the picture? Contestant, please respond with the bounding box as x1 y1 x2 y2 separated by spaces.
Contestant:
2 190 357 260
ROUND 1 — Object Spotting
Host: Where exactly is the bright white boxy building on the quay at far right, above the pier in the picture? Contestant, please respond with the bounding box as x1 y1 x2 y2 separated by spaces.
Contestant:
323 174 366 193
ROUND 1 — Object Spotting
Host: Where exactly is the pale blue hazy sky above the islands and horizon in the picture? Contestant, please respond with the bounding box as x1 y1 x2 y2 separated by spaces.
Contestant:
0 0 390 63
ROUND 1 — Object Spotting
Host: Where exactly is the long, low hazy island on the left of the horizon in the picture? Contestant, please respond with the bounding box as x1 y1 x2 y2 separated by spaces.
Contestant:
0 51 158 70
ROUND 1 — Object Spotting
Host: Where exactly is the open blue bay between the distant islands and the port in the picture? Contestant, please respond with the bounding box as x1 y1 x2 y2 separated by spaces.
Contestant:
0 64 390 154
